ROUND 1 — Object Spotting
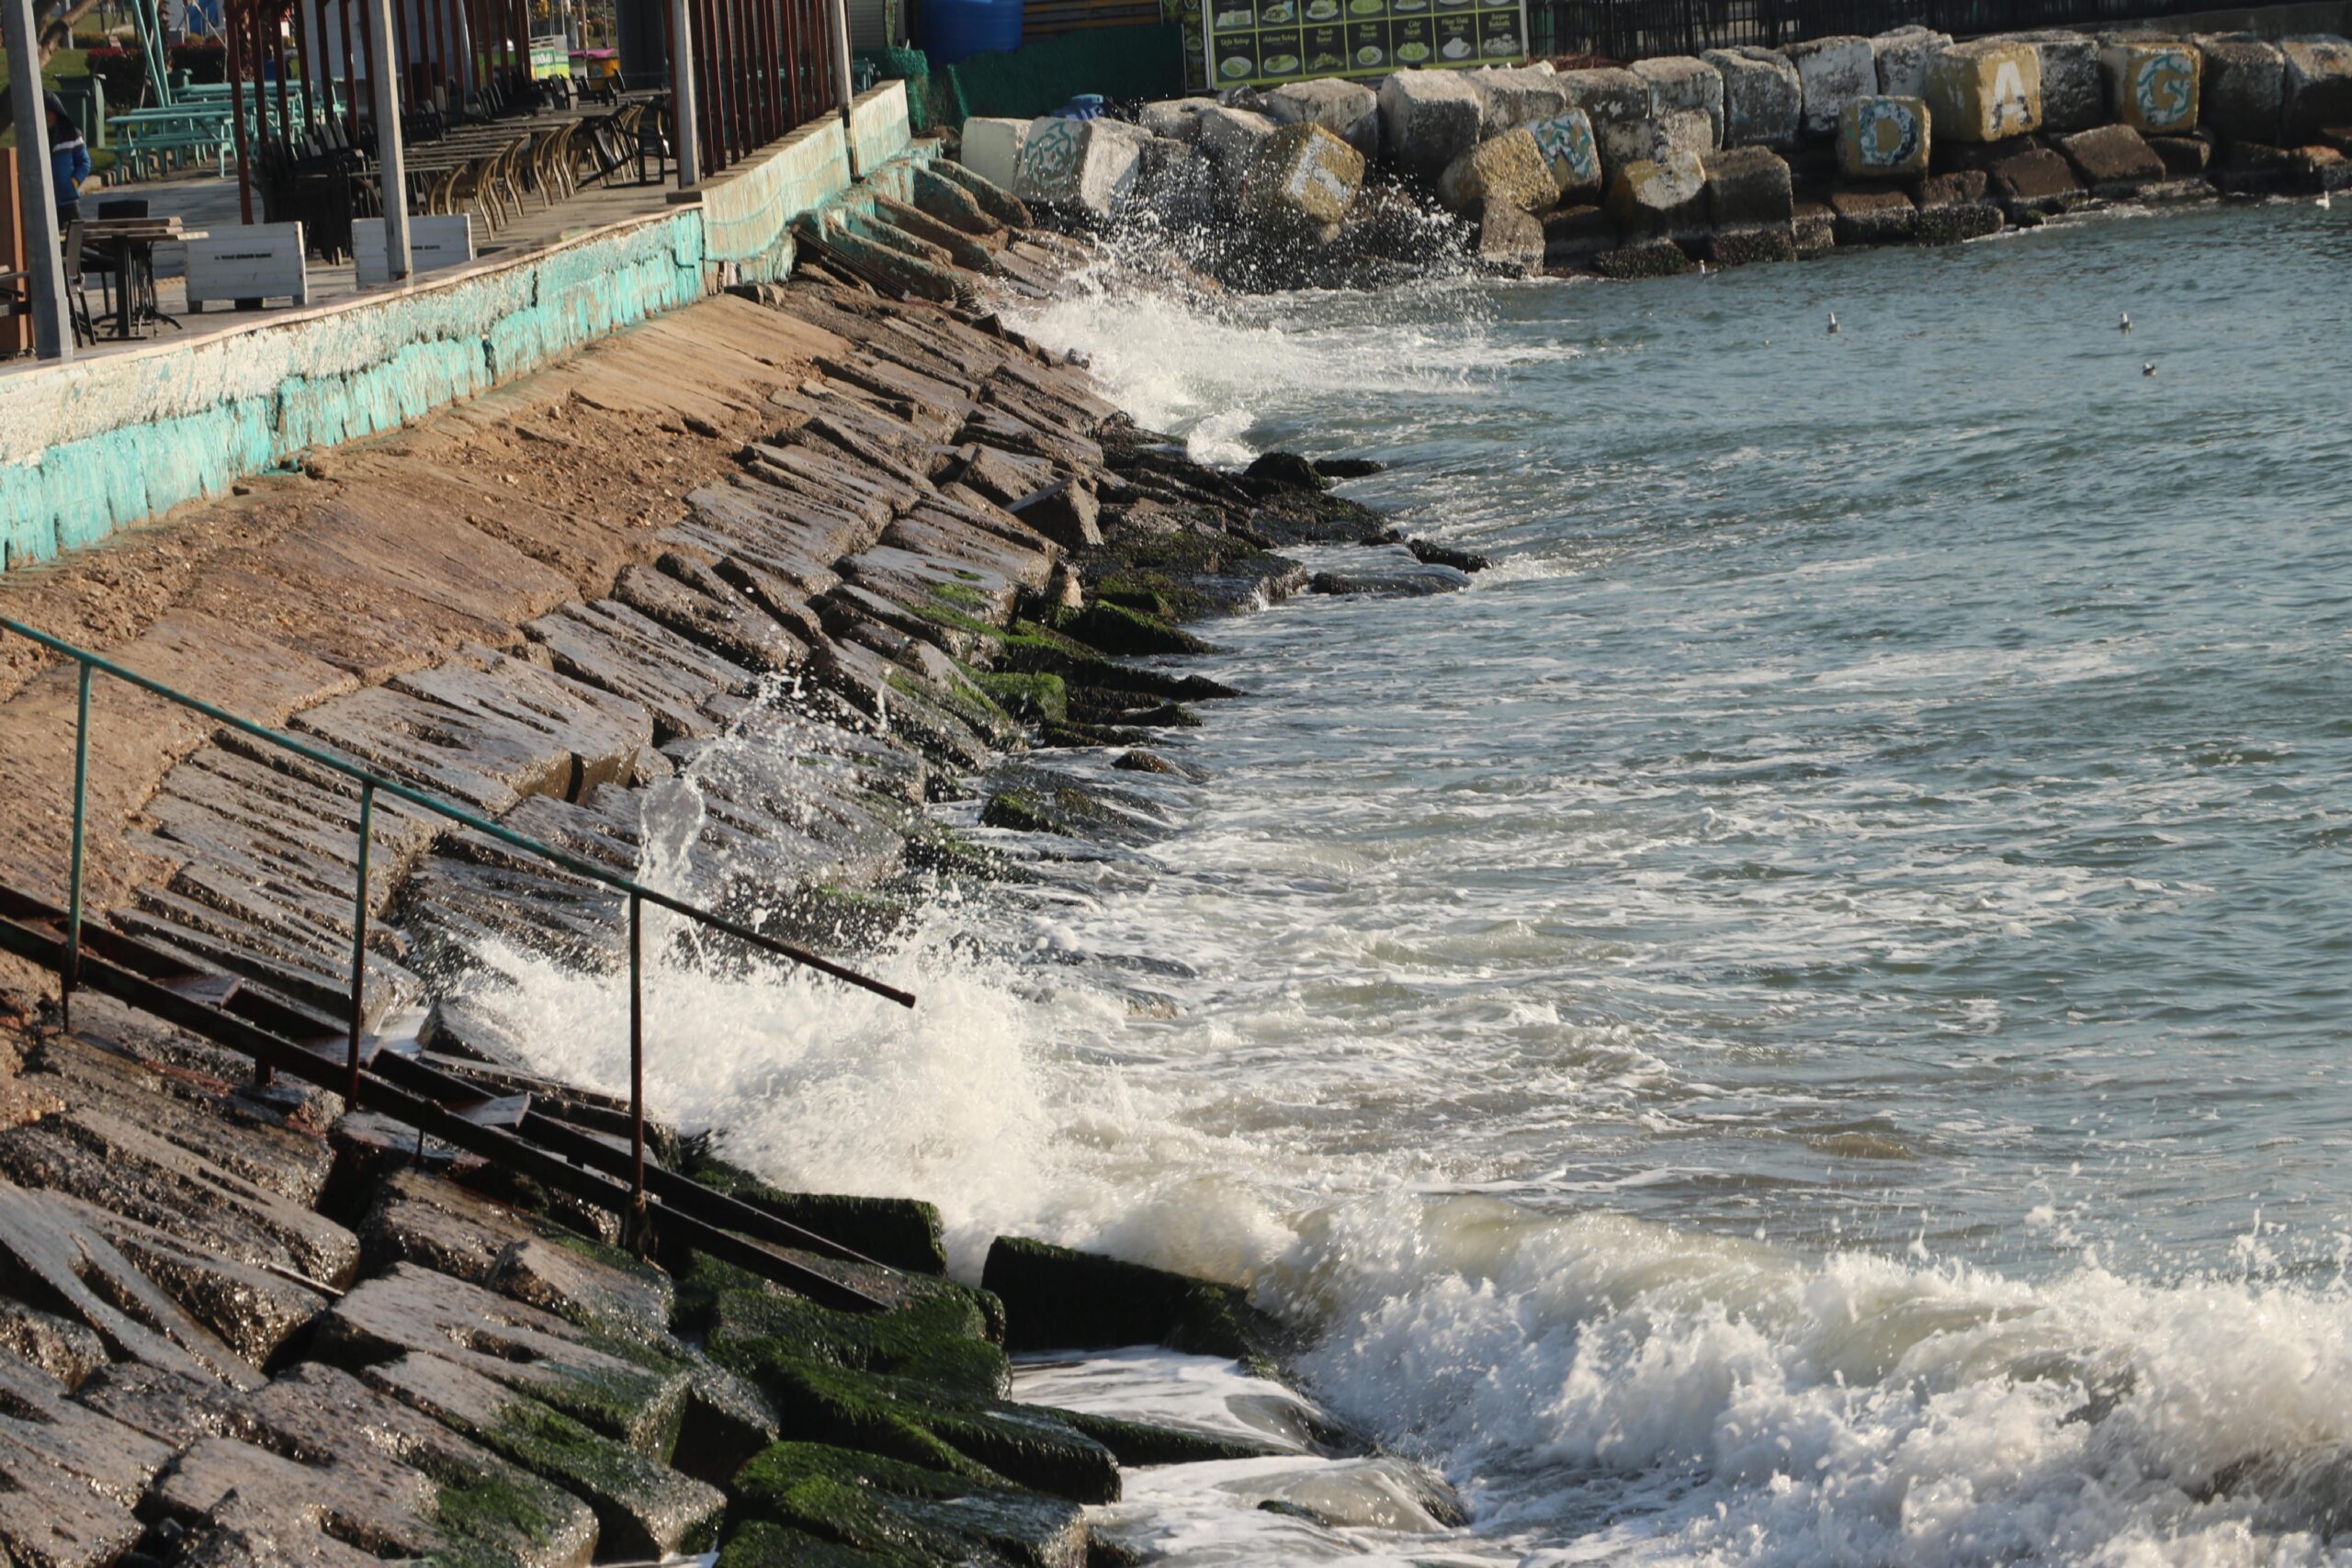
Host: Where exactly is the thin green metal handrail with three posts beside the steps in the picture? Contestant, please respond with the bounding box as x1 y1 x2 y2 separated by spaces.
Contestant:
0 616 915 1218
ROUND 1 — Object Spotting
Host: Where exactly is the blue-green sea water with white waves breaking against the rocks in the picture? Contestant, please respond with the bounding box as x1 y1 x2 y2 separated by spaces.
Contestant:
486 202 2352 1563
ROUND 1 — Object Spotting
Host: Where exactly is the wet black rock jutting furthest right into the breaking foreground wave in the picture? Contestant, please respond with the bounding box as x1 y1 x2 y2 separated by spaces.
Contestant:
981 1236 1284 1371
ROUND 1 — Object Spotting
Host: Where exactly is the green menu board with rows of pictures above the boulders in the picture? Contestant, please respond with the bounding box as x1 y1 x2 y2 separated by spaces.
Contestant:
1200 0 1526 87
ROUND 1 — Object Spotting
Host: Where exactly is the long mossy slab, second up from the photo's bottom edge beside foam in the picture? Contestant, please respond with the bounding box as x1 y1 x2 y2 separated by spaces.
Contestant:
767 1361 1120 1502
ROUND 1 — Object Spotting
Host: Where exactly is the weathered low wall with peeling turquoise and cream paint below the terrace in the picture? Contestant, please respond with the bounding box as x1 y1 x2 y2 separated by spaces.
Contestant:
0 83 912 571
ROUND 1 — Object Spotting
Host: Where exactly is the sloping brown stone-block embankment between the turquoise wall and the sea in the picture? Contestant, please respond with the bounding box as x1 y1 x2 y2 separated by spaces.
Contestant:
0 186 1463 1568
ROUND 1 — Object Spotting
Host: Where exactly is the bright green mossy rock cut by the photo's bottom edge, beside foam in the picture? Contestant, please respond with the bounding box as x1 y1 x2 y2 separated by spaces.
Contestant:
722 1443 1087 1568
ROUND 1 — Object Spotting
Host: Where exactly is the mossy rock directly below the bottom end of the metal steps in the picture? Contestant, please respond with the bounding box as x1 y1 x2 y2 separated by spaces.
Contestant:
708 1291 1012 1399
